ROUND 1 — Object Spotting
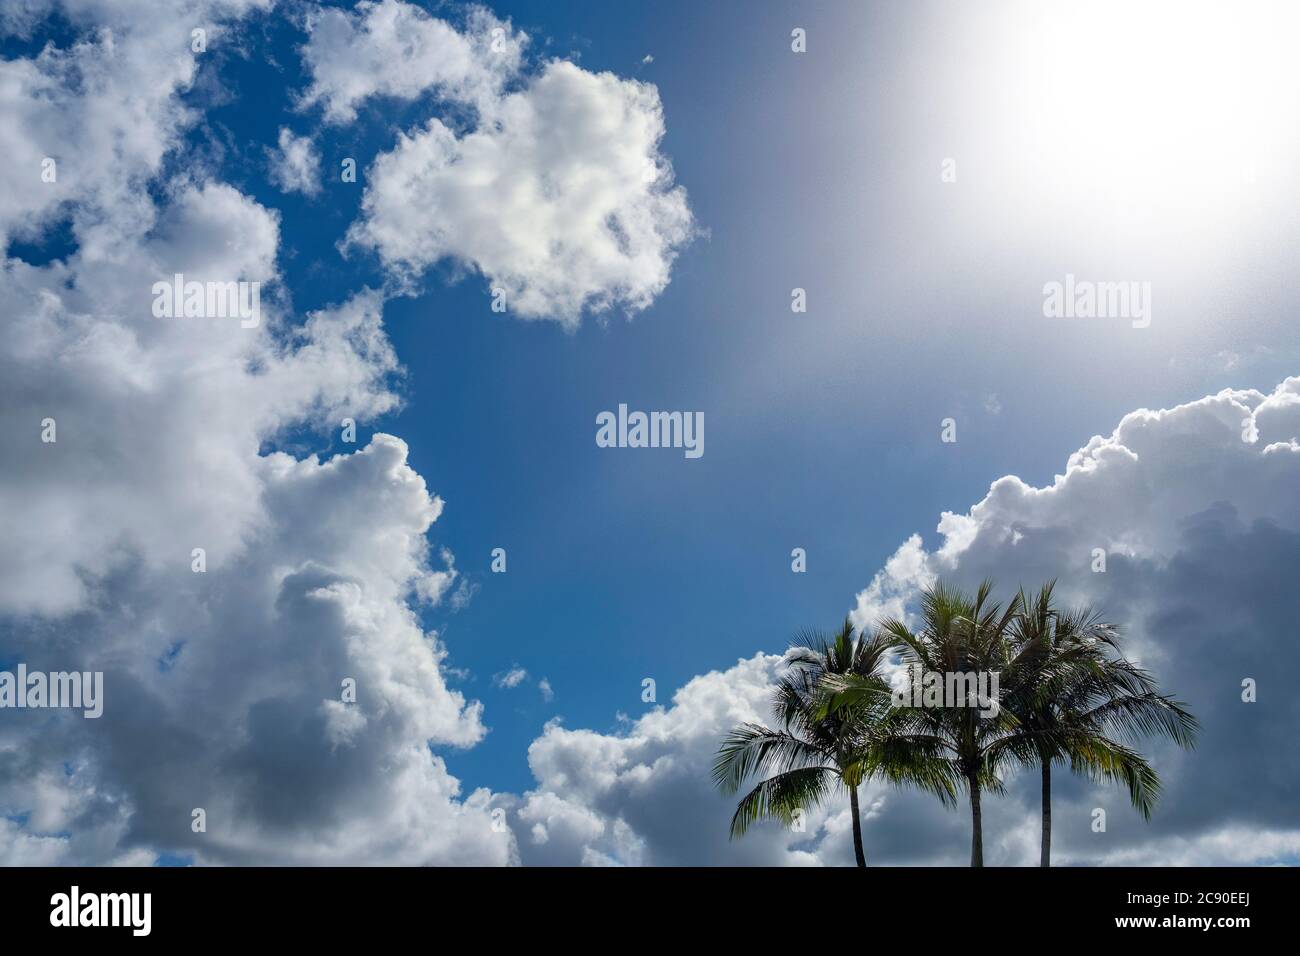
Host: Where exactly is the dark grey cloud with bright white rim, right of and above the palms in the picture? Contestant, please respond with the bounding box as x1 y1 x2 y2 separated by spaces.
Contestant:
858 378 1300 864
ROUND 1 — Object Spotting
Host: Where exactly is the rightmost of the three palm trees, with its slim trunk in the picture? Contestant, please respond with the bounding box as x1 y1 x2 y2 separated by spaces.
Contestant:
1004 581 1199 866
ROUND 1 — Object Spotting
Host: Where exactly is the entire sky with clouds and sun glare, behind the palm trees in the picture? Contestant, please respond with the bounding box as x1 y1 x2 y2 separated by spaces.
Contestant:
0 0 1300 865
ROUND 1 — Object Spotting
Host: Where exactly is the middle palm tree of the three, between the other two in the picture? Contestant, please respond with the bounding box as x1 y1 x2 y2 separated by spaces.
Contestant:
823 581 1023 866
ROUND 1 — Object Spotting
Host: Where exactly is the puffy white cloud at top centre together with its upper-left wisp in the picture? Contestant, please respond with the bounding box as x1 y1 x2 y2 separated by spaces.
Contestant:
303 0 694 326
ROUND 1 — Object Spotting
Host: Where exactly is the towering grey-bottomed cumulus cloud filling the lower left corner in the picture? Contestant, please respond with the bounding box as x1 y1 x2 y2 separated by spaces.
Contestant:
0 434 511 864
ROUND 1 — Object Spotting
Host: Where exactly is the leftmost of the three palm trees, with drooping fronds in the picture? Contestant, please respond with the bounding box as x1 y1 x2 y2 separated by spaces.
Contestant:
714 620 954 866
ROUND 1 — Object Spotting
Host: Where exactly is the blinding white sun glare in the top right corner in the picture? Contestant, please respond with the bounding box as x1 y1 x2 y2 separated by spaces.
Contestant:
976 1 1300 247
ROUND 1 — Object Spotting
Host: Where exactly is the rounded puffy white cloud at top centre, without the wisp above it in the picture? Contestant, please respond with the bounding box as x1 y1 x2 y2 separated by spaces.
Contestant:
348 61 693 325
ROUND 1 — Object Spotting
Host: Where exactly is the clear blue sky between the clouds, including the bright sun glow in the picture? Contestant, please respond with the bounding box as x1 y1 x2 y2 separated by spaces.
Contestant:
0 3 1300 861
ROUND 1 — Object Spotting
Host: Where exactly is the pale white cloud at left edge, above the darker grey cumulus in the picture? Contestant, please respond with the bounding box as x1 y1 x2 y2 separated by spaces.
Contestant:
0 183 397 613
